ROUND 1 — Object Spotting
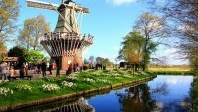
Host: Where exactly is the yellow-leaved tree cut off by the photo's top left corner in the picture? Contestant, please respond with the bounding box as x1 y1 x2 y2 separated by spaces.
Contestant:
0 0 20 42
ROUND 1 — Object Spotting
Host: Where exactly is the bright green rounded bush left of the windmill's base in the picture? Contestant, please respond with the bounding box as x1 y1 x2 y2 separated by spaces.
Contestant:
26 50 44 62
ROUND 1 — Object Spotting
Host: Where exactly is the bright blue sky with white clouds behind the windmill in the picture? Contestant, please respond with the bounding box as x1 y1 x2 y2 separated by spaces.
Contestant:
15 0 189 64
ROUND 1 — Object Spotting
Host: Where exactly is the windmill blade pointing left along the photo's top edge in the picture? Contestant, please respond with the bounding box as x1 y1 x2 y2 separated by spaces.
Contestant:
26 0 59 10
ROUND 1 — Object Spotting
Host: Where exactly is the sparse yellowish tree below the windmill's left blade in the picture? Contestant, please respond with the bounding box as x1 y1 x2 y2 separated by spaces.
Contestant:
18 15 50 50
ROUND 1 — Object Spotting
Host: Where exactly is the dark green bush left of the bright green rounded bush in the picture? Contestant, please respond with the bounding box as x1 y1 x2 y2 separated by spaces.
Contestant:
8 46 27 66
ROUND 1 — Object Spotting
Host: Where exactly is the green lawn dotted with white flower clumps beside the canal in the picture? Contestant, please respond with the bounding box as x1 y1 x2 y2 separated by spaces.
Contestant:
0 70 153 108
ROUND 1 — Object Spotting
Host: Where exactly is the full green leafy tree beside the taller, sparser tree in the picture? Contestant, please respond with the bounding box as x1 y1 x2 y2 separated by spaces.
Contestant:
117 31 145 64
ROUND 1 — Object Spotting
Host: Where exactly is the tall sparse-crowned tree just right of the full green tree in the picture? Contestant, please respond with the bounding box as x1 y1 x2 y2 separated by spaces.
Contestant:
134 12 169 71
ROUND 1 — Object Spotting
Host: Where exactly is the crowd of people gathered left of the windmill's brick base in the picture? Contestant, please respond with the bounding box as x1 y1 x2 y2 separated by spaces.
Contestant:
0 60 57 81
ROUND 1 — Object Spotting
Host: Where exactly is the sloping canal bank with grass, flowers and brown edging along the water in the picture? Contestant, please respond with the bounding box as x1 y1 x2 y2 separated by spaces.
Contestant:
0 71 155 111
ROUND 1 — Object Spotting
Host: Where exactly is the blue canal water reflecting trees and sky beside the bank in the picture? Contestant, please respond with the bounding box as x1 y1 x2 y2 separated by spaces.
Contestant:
17 75 193 112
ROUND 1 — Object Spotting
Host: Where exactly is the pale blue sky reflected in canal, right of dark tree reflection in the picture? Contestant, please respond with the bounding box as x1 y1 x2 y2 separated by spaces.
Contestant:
148 75 193 112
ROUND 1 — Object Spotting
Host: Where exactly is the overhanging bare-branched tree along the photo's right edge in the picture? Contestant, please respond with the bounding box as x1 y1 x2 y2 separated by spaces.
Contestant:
144 0 198 73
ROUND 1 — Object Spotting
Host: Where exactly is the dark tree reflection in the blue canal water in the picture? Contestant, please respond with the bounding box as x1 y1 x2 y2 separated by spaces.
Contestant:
116 84 156 112
